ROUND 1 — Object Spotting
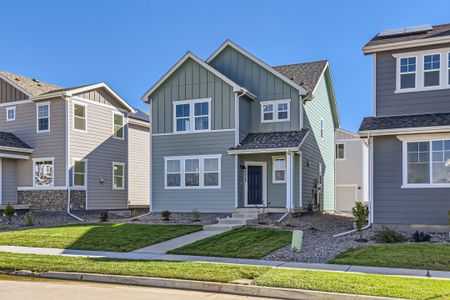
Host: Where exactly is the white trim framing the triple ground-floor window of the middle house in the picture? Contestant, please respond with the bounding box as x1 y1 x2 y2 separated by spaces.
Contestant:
164 154 222 190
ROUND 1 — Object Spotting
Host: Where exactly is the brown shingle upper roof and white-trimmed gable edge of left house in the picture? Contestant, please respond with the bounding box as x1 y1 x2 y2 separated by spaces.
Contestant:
0 70 134 112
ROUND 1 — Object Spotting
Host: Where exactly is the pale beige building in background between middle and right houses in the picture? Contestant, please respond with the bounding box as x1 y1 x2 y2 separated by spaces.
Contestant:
335 128 369 212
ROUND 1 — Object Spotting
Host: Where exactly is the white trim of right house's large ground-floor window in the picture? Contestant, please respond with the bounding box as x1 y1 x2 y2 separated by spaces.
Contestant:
401 139 450 189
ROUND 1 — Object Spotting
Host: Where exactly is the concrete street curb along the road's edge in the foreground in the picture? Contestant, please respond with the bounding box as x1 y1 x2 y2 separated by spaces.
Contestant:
0 271 398 300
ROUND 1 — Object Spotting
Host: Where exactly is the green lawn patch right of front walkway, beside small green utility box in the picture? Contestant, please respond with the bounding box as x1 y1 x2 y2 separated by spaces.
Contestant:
169 227 292 258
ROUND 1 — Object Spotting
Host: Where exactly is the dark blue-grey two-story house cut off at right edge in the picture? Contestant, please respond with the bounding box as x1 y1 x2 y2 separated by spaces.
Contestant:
359 24 450 230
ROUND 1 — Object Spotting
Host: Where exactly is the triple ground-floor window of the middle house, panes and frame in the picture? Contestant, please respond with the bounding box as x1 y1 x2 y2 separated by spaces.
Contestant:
164 155 221 189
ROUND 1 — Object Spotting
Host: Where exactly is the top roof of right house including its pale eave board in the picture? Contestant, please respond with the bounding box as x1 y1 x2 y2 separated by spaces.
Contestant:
363 24 450 54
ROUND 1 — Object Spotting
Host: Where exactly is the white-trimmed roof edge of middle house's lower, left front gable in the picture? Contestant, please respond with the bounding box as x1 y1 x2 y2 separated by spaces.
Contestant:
142 51 256 102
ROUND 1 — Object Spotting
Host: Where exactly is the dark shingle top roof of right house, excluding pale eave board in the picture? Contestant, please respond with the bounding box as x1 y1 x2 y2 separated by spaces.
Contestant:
364 24 450 47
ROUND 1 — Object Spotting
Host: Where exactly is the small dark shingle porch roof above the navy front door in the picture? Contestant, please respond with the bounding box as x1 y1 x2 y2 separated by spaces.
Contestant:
229 129 308 150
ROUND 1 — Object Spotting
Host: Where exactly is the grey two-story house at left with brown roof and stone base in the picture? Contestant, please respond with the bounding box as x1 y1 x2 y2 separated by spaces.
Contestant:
0 71 149 210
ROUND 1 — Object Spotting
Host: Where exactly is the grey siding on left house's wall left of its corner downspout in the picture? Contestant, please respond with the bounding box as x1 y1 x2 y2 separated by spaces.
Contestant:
0 98 66 187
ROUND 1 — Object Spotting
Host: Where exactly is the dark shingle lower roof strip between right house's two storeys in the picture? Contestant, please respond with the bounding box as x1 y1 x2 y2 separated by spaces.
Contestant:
359 112 450 131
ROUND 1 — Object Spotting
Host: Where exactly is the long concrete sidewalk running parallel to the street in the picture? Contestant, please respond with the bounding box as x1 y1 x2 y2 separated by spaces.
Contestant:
0 246 450 279
